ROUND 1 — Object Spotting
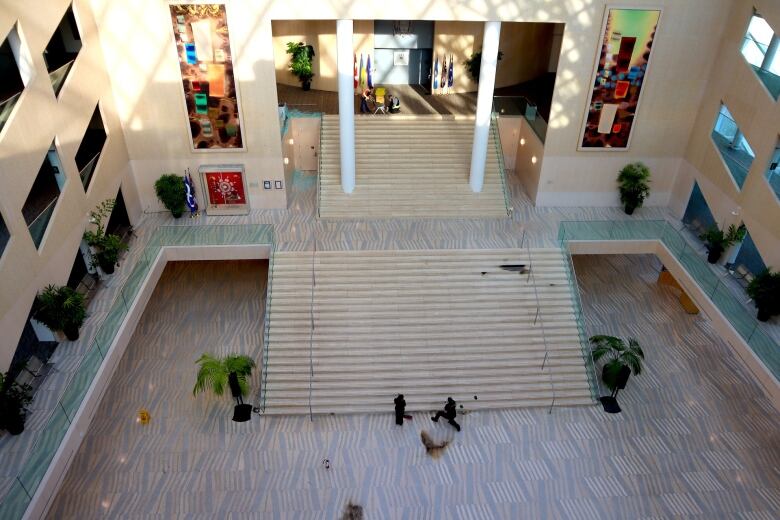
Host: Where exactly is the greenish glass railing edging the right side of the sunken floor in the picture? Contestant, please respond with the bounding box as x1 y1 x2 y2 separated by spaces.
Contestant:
558 220 780 379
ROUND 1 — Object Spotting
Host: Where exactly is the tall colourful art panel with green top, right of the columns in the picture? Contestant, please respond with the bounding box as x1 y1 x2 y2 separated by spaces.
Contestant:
579 7 661 150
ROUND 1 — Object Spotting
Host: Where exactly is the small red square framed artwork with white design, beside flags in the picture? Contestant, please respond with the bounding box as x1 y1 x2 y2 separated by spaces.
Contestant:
198 165 249 215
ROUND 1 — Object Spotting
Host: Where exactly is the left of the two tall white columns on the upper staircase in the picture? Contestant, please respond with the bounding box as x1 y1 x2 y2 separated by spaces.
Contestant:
336 20 355 193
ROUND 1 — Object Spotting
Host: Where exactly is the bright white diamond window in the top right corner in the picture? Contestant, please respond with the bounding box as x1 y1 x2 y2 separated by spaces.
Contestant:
742 13 780 101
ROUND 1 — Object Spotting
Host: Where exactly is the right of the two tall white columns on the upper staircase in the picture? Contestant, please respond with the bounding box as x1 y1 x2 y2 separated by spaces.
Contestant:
469 22 501 193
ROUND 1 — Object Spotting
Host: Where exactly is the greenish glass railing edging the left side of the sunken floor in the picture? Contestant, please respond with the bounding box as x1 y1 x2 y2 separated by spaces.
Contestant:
0 225 274 520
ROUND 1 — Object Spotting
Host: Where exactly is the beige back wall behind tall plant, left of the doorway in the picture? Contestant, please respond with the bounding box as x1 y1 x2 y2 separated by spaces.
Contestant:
272 20 374 92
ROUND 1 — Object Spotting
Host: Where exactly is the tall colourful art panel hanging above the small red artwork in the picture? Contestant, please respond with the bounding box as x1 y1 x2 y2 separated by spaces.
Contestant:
171 4 244 149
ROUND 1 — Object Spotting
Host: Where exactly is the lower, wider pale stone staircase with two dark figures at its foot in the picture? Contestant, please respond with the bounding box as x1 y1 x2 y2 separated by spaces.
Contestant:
263 249 592 414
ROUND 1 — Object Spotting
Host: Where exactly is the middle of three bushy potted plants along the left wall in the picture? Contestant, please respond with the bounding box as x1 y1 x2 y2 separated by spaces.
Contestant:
35 285 87 341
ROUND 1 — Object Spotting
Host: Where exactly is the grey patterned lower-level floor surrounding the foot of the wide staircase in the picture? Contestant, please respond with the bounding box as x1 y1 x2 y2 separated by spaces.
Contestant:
49 257 780 519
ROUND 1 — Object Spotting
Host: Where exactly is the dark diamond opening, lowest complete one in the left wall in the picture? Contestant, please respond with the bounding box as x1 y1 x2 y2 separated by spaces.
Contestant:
22 144 65 247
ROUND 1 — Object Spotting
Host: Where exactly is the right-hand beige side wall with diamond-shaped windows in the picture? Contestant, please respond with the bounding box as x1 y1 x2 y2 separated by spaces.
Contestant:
675 0 780 269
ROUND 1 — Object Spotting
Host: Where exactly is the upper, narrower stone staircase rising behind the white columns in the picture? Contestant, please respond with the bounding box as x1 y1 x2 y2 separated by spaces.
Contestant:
318 114 507 218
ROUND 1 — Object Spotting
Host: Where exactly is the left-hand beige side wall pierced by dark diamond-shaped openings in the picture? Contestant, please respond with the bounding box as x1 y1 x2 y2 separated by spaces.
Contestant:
0 0 133 371
